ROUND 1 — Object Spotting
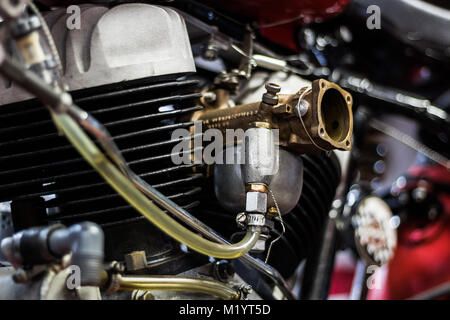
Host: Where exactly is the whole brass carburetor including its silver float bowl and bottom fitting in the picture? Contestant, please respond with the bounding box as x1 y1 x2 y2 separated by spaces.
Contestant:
191 79 353 251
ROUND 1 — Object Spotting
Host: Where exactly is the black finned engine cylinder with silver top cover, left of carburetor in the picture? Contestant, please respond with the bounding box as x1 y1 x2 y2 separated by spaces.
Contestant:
1 4 201 260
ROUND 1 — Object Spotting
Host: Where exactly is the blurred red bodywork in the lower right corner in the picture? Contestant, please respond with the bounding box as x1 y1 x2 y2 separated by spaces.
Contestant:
368 166 450 299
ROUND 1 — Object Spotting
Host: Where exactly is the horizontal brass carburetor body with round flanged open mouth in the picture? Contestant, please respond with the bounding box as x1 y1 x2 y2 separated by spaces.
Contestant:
191 79 353 153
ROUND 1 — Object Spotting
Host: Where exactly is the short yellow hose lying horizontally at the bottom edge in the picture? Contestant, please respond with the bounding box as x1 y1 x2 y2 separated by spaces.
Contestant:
117 275 240 300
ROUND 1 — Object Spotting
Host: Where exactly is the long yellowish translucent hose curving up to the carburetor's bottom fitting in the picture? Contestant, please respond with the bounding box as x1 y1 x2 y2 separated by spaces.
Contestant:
53 113 260 259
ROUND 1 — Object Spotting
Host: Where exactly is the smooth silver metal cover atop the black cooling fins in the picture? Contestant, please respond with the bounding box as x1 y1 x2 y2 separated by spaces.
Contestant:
0 3 195 104
